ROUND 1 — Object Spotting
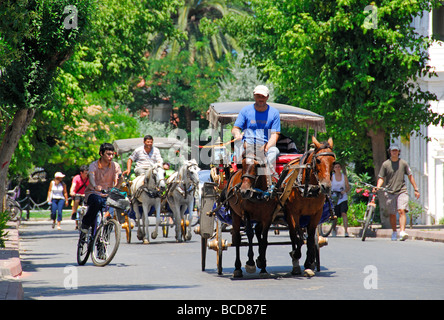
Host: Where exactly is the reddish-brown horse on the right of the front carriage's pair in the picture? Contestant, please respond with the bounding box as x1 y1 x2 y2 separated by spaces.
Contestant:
284 137 335 277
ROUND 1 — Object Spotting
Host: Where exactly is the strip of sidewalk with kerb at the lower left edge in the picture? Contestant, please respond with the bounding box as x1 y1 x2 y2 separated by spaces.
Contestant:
0 222 23 300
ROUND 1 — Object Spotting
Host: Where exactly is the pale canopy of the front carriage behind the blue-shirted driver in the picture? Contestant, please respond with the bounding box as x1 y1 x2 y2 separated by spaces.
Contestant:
207 101 326 132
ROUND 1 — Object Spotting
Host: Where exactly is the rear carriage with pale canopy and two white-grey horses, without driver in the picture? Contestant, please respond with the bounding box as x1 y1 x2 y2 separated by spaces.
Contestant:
113 137 200 243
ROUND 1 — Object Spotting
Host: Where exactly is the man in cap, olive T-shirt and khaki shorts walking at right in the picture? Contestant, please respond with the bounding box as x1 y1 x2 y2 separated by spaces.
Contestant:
376 145 420 241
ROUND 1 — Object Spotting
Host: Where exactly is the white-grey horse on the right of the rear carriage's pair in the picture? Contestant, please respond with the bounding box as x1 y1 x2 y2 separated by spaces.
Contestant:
167 159 200 242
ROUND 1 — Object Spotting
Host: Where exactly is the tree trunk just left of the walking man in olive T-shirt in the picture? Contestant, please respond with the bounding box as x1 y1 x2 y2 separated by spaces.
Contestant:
367 124 391 229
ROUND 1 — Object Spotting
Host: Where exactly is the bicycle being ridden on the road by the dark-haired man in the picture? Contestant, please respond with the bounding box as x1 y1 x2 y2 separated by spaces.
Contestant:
77 191 121 267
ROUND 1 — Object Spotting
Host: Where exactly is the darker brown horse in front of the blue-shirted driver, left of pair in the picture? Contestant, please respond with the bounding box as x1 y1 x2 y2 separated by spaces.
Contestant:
226 155 277 278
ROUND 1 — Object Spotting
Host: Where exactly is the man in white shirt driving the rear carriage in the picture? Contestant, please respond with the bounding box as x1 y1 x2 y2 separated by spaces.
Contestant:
123 135 163 176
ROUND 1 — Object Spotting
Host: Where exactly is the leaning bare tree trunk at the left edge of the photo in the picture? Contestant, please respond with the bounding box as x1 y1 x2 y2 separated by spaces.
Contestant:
0 109 35 209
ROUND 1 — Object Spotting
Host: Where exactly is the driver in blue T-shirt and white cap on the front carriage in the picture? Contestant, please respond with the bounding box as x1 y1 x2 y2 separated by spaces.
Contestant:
231 85 281 181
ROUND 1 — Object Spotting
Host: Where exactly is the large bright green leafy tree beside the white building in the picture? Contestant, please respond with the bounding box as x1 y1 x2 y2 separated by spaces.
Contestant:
229 0 442 175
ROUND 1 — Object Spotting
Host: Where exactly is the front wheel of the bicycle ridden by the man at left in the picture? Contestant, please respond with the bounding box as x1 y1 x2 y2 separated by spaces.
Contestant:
91 219 121 267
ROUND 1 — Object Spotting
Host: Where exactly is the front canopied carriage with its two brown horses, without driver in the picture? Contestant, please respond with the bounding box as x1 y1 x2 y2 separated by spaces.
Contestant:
195 102 335 277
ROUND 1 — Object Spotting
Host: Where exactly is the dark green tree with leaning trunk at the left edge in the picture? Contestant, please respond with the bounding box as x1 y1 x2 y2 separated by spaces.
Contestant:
0 0 94 199
